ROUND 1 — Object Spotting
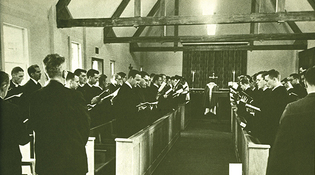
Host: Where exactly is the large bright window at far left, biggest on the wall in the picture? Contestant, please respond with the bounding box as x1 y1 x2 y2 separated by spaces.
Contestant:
2 24 29 84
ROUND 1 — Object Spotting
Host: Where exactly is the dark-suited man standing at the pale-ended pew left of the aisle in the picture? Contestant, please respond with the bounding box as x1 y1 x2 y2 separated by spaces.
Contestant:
114 70 141 138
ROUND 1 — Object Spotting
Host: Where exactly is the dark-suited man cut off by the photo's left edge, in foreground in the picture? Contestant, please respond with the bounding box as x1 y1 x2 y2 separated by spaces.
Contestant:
0 71 29 175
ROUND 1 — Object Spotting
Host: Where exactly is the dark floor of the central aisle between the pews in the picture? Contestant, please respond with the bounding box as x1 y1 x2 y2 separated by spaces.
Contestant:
153 117 236 175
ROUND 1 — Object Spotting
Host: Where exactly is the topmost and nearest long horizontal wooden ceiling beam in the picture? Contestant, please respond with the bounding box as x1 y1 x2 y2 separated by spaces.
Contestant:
57 11 315 28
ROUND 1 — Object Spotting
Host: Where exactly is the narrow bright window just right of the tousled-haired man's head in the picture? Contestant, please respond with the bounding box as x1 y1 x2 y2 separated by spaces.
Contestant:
71 42 82 72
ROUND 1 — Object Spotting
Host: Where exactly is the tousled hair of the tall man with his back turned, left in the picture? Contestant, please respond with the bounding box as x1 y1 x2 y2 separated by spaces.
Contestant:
43 54 65 78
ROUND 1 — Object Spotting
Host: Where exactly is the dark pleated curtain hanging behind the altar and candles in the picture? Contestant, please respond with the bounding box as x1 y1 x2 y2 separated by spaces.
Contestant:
183 50 247 88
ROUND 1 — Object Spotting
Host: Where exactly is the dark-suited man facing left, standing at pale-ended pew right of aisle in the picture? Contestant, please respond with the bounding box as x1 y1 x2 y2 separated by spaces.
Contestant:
259 69 289 146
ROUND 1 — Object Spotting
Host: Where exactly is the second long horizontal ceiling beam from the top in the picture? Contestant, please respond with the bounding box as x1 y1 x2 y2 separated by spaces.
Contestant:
105 33 315 43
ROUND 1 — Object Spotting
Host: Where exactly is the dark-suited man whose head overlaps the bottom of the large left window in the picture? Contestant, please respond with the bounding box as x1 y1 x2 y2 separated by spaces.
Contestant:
5 67 24 105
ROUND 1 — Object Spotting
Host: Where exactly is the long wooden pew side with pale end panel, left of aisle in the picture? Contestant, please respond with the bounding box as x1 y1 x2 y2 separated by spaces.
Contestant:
115 105 185 175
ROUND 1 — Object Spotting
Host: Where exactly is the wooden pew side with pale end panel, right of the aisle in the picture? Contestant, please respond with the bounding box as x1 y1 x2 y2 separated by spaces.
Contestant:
231 106 270 175
